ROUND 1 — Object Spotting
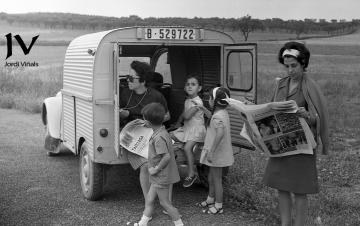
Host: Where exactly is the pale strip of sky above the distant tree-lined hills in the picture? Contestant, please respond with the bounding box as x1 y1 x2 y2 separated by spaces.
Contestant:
0 0 360 21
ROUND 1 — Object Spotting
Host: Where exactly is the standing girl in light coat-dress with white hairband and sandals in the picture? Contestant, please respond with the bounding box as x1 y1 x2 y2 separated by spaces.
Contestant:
196 87 234 214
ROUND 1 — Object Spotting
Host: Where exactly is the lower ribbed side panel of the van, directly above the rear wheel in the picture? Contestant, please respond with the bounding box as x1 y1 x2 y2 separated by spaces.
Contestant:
76 98 94 159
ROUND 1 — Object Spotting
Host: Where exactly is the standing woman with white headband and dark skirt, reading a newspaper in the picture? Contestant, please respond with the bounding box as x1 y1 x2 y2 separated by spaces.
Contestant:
264 42 329 226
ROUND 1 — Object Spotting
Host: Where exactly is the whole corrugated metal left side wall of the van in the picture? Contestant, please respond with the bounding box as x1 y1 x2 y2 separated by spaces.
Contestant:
63 35 99 159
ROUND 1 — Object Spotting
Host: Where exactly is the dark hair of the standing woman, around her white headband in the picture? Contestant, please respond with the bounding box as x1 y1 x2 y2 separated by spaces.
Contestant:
278 42 310 69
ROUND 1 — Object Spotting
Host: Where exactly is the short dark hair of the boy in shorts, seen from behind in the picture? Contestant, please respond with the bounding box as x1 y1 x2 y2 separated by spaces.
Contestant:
141 103 166 126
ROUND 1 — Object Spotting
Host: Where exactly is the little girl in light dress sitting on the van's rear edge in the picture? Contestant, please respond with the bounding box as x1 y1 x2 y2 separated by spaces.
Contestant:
171 75 206 187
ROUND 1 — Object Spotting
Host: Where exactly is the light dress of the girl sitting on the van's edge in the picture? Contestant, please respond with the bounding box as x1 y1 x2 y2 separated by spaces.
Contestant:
172 96 206 143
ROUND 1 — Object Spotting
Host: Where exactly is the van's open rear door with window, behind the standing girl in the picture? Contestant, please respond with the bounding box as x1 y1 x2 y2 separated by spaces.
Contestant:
223 44 257 149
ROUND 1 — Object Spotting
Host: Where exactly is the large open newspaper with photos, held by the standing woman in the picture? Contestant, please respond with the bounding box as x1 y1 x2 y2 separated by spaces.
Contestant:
226 98 316 157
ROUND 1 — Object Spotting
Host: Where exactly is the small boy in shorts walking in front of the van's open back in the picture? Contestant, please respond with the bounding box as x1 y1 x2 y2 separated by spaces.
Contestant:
134 103 184 226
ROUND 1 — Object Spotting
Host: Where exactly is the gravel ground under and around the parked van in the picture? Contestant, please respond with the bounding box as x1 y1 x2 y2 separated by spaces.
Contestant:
0 109 258 226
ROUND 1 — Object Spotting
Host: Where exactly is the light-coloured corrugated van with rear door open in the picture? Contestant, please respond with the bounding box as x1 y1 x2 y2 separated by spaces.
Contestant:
42 26 257 200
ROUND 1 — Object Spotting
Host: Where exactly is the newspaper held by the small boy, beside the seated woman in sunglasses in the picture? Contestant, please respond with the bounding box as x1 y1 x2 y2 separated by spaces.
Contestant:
119 119 153 159
